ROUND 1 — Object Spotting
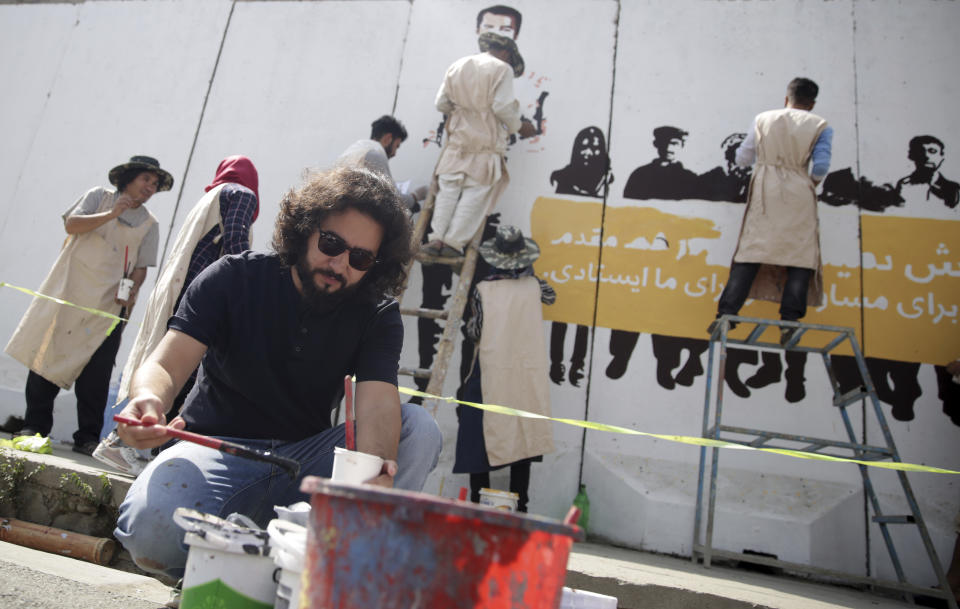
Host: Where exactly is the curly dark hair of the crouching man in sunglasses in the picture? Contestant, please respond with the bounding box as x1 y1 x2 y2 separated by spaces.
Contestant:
271 167 413 300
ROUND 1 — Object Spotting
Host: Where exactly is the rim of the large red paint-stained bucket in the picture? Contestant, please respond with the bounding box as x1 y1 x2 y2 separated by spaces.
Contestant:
300 476 586 541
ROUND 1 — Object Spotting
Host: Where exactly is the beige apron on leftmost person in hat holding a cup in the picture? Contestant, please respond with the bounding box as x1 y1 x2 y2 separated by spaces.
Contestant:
6 191 157 389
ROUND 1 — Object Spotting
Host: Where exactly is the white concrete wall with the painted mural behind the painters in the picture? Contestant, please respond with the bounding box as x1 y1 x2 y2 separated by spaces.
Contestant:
0 0 960 585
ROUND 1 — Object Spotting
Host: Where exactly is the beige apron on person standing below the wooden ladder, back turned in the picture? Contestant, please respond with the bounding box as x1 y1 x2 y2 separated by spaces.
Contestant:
477 277 553 467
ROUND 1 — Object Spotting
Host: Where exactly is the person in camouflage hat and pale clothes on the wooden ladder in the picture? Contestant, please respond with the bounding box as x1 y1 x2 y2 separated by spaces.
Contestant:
420 32 536 256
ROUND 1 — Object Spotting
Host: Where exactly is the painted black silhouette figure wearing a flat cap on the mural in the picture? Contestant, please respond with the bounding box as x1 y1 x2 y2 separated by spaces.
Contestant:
623 125 698 200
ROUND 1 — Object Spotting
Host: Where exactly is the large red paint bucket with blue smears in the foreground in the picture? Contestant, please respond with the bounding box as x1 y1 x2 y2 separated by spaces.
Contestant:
300 477 583 609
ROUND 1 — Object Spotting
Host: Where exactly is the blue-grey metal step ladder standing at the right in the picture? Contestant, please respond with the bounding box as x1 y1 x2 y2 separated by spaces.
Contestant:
692 315 957 609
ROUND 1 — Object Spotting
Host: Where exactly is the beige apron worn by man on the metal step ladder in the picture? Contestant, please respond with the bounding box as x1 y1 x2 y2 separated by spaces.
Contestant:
733 108 827 306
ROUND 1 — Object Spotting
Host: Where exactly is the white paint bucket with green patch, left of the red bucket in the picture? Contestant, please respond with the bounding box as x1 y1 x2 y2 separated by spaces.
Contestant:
173 508 277 609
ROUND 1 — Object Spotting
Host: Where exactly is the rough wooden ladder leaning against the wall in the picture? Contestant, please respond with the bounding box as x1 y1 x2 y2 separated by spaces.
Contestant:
397 188 485 414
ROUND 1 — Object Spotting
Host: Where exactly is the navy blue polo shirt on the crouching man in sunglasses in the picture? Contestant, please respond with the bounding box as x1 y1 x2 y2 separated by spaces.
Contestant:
167 252 403 441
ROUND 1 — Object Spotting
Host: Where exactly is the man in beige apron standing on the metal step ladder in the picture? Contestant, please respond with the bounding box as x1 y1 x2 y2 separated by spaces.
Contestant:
707 78 833 345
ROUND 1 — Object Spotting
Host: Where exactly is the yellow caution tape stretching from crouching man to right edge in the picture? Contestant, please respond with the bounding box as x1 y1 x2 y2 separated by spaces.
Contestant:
397 387 960 474
